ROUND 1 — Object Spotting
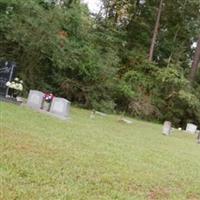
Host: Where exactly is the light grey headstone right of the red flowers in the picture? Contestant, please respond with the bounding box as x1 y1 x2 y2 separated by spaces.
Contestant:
50 97 71 119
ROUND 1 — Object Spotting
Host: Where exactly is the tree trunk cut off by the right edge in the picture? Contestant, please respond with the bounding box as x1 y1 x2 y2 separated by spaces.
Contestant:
190 37 200 82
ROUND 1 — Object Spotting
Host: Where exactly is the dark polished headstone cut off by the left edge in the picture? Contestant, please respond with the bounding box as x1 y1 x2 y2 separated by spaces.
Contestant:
0 61 16 97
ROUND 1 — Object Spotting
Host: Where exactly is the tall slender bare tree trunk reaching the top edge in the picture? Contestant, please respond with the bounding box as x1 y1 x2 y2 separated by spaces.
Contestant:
149 0 164 62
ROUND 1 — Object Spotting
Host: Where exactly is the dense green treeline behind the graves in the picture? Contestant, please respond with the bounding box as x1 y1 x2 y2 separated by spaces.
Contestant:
0 0 200 125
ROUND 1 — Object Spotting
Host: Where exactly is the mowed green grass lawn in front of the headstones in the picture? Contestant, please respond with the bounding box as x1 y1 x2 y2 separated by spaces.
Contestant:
0 103 200 200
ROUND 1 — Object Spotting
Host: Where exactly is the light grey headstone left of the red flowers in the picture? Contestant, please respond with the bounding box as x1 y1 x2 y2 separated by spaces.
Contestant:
27 90 44 109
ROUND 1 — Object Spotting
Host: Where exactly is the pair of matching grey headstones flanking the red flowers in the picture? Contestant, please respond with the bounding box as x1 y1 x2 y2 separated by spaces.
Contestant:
27 90 71 119
